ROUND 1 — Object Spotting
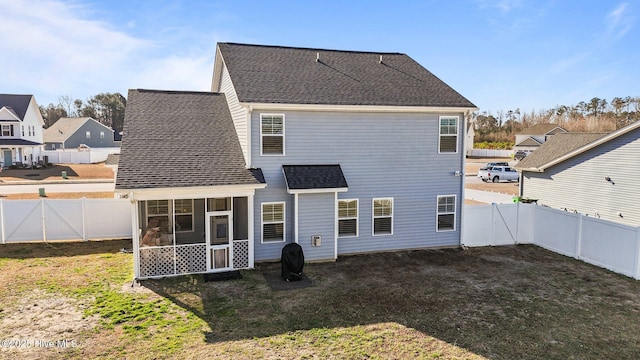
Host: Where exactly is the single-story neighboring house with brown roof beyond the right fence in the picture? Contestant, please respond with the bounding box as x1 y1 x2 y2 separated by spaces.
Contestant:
516 122 640 226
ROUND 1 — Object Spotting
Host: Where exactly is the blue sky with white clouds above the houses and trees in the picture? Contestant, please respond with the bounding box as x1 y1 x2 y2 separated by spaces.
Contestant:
0 0 640 114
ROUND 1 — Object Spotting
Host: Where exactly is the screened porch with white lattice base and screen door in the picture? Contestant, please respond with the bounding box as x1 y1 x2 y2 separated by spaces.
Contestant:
134 196 253 279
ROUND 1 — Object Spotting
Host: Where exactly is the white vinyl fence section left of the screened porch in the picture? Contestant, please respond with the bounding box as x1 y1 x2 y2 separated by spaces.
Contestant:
0 198 131 244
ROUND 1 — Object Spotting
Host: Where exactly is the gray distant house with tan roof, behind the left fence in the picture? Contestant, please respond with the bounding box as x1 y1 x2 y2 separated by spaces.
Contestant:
44 117 118 150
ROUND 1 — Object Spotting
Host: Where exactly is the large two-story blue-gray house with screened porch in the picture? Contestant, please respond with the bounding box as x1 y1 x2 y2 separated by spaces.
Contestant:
116 43 476 278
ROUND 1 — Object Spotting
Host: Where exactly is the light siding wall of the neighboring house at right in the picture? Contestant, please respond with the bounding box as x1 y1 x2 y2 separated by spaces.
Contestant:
522 129 640 226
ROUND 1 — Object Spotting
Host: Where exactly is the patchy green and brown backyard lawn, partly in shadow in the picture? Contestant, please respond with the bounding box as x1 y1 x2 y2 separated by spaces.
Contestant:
0 241 640 359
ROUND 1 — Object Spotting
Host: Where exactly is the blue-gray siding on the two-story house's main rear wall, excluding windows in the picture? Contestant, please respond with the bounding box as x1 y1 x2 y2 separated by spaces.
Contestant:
251 110 464 260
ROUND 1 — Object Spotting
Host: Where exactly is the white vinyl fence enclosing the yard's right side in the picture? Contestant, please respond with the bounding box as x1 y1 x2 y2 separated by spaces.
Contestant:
462 203 640 280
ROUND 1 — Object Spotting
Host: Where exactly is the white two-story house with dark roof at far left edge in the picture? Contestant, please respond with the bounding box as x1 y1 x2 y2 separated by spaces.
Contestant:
0 94 44 168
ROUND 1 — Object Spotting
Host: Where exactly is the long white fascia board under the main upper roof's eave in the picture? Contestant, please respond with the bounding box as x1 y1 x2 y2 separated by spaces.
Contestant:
240 102 478 114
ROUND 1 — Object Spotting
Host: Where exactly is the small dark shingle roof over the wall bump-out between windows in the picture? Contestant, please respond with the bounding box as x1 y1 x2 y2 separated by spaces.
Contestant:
282 165 348 190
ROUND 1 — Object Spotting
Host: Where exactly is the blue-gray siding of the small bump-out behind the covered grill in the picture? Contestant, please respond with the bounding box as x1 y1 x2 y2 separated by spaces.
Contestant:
294 193 336 261
